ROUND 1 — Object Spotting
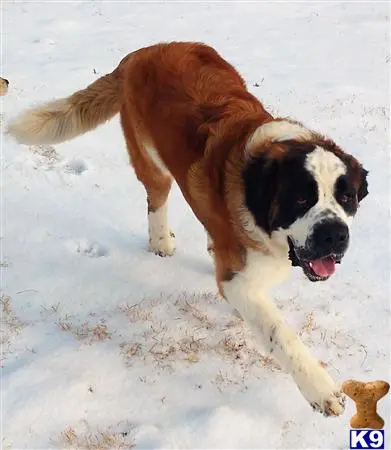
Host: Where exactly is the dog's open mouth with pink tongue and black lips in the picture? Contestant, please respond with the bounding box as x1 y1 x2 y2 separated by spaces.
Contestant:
288 239 343 281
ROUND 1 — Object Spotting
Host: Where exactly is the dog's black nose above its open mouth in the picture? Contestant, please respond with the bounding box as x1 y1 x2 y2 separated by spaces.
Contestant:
312 220 349 254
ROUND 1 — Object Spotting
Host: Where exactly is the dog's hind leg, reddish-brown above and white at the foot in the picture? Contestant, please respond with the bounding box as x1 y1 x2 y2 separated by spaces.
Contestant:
121 113 175 256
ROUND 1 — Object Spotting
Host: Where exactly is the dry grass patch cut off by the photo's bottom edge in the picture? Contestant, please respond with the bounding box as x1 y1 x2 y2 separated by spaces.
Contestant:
56 426 134 450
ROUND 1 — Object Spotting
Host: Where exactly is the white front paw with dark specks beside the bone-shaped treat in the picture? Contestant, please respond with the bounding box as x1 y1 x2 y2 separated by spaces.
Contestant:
294 360 345 417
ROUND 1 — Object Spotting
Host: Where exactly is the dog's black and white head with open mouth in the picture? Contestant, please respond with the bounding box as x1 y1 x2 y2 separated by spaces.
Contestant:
243 121 368 281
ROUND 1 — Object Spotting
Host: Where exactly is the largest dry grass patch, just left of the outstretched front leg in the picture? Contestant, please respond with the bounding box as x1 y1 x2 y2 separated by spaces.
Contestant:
120 293 281 373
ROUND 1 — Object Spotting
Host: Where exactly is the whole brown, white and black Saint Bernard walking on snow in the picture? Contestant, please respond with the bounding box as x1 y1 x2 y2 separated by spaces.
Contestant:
8 42 368 416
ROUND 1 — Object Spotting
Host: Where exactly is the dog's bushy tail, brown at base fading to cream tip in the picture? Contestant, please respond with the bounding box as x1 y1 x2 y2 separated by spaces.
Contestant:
7 70 122 145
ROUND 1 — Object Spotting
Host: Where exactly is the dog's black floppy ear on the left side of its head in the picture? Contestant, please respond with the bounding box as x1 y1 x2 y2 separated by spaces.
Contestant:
242 155 279 234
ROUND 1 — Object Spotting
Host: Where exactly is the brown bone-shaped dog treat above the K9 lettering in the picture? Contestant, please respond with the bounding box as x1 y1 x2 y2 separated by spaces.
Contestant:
342 380 390 430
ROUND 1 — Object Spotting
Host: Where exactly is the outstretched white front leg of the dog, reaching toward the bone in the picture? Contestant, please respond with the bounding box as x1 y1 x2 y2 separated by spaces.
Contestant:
221 269 344 416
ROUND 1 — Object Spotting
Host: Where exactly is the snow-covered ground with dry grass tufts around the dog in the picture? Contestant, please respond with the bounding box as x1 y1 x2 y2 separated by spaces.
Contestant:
0 1 390 449
